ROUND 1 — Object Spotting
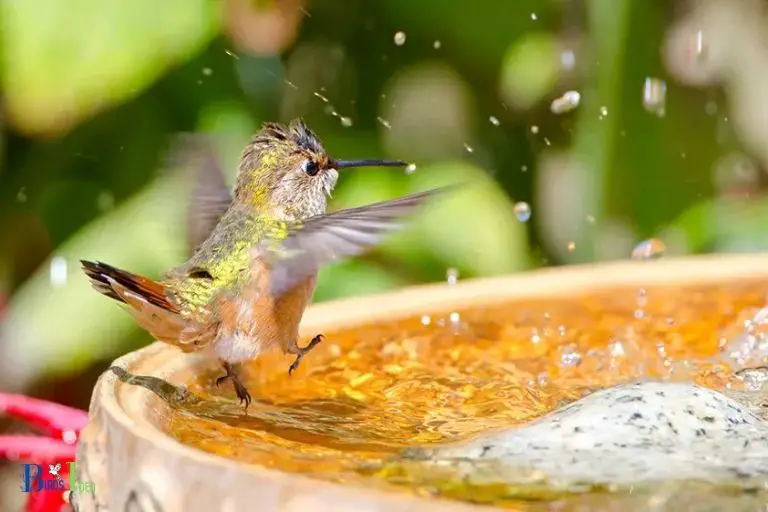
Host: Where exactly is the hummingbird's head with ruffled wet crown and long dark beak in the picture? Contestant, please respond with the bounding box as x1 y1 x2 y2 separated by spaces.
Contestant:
235 119 407 220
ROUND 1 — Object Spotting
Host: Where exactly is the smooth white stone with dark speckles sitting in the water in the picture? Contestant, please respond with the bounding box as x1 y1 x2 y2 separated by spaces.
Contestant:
405 382 768 488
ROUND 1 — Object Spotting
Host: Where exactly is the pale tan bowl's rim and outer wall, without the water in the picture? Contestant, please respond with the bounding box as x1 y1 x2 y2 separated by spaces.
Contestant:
70 255 768 512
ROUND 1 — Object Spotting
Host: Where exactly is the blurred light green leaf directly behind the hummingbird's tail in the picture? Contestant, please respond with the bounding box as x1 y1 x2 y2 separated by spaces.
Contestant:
0 177 187 389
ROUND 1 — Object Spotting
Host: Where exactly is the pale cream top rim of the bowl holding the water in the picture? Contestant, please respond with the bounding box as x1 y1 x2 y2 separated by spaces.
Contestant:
85 253 768 512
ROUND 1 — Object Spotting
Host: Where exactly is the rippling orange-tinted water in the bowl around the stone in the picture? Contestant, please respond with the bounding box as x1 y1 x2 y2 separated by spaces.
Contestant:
159 281 768 510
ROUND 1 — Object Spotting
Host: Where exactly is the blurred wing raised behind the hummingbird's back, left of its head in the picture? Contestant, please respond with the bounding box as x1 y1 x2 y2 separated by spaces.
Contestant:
171 134 232 253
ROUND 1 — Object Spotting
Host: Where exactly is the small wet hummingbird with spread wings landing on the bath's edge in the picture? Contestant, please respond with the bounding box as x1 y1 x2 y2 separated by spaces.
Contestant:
81 119 447 412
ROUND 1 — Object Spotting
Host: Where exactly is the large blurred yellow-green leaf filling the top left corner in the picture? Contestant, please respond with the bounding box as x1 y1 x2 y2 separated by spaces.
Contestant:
0 0 221 135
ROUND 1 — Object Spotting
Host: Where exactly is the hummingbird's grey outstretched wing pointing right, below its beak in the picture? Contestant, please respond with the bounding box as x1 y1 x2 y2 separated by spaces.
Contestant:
256 186 454 297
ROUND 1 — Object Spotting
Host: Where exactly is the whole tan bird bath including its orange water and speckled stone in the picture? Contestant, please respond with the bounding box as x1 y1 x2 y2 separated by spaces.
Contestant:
75 255 768 512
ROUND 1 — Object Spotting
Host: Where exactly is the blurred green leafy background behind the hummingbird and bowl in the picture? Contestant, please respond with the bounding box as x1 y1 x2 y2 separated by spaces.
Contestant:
0 0 768 482
